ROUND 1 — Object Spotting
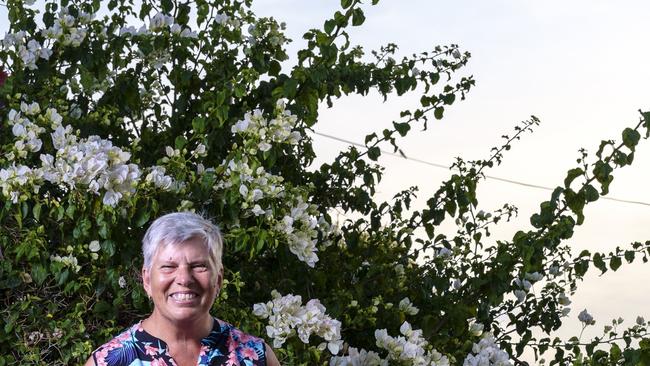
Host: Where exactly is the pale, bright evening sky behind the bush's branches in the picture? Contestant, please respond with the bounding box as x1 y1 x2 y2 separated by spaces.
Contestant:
0 0 650 360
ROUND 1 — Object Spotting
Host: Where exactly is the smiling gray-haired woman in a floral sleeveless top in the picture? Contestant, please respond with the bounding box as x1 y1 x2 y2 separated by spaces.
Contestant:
86 212 280 366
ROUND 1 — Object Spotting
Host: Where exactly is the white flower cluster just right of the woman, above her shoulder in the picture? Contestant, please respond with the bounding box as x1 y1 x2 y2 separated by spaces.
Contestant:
253 290 343 354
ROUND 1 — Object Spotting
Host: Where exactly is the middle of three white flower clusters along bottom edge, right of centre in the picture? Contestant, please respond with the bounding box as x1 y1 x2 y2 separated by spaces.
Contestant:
375 322 449 366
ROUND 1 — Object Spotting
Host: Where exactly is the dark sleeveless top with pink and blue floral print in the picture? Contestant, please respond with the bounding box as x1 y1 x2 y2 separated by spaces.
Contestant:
92 319 266 366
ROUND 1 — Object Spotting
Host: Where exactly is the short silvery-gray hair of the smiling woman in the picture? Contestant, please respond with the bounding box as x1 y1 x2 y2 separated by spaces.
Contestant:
142 212 223 272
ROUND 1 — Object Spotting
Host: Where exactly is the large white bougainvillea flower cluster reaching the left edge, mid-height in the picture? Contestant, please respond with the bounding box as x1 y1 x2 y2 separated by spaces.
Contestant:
0 103 184 206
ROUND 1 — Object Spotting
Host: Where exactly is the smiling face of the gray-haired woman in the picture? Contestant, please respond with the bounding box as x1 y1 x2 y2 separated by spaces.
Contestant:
142 238 223 322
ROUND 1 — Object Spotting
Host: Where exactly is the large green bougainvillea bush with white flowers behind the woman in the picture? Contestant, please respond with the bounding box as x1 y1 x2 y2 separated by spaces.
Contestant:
0 0 650 365
